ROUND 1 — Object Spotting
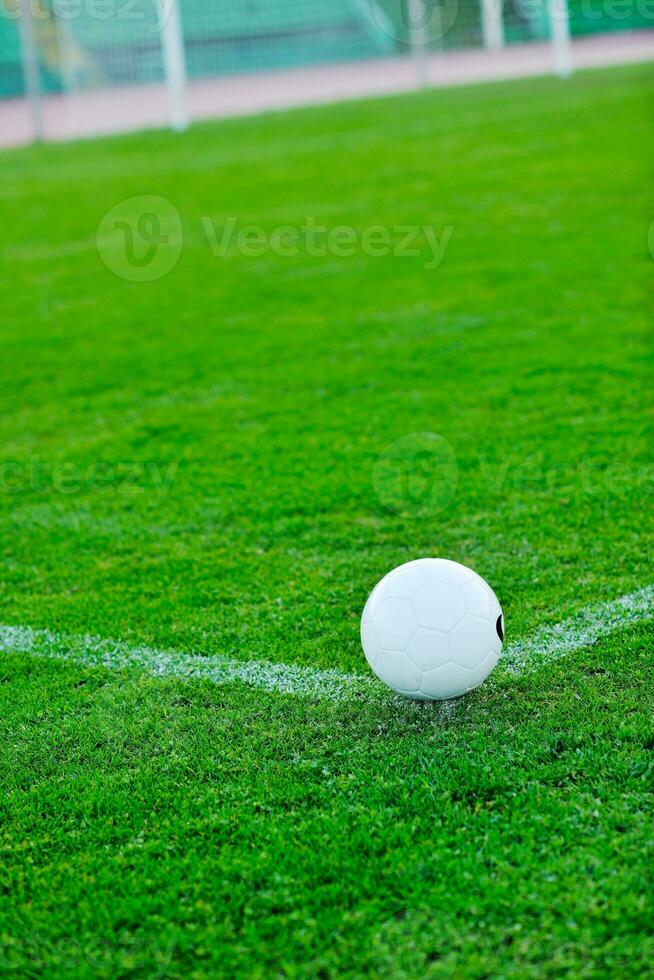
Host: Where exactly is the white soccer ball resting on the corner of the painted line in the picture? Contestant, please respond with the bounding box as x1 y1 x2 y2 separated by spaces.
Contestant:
361 558 504 701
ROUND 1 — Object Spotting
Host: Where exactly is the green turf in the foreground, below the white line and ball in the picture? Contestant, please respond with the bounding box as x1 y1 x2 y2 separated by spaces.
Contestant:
0 629 654 977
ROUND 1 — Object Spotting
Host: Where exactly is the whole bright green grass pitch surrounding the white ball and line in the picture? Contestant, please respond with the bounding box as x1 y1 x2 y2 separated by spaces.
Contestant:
0 66 654 978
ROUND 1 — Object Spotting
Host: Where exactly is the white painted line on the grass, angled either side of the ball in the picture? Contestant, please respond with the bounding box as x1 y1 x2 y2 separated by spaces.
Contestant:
0 585 654 701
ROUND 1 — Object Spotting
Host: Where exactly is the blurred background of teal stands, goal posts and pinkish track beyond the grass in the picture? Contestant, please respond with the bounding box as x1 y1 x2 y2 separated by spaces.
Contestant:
0 0 654 145
